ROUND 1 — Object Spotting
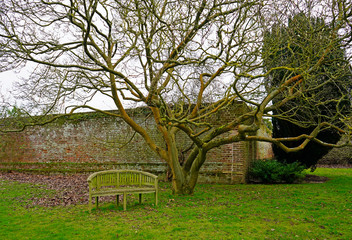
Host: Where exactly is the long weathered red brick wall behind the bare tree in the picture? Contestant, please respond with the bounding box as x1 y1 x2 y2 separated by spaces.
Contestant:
0 109 272 182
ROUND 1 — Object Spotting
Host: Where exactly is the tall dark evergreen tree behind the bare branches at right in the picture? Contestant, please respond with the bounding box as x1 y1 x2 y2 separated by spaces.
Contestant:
263 13 352 168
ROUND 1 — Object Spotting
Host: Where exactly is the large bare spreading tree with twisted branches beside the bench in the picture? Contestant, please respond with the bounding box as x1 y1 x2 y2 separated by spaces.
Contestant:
0 0 352 194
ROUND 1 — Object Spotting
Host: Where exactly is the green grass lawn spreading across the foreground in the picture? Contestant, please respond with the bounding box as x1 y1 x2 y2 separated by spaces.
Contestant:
0 169 352 239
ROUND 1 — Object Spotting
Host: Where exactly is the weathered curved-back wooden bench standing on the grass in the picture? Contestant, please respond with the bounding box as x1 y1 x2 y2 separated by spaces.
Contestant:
87 170 158 212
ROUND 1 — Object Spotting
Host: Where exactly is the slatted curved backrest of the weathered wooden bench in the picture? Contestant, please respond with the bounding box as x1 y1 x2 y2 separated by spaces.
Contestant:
87 170 158 189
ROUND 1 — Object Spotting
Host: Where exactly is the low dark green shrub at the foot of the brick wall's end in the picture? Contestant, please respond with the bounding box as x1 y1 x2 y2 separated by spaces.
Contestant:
249 160 305 183
